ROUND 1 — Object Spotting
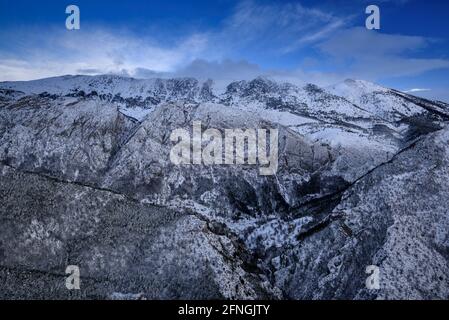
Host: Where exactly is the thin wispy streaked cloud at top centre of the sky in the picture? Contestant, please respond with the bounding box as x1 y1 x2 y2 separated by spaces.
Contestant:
219 1 351 53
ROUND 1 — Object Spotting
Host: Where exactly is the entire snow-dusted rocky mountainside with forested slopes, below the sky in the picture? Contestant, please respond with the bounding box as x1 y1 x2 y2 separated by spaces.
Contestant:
0 76 449 299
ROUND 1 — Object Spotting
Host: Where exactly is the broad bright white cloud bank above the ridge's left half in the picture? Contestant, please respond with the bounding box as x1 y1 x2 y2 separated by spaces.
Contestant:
0 28 207 80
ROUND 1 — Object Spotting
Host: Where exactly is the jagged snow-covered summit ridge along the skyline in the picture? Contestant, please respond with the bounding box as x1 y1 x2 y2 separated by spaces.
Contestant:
0 75 444 118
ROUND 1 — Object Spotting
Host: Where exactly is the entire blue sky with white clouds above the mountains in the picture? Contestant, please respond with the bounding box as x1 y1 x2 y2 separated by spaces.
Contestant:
0 0 449 101
